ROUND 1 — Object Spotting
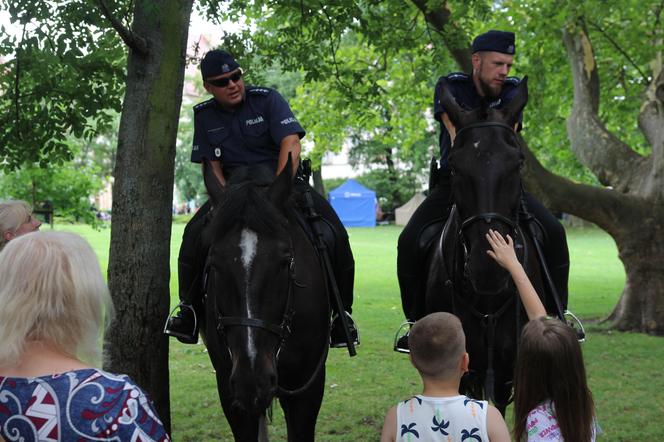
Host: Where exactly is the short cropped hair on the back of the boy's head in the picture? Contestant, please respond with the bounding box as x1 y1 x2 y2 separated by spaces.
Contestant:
408 312 466 378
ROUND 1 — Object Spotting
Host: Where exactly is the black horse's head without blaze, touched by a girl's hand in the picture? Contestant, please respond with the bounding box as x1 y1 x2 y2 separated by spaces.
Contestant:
443 77 528 294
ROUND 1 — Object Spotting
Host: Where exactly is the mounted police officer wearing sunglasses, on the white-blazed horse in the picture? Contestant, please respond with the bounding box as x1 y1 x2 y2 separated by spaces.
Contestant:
164 50 357 347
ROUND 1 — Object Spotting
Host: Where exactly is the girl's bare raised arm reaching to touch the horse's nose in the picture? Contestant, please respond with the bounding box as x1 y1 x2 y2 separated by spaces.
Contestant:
486 229 546 320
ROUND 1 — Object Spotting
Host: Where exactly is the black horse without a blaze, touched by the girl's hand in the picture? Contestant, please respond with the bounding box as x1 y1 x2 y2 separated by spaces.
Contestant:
425 78 544 412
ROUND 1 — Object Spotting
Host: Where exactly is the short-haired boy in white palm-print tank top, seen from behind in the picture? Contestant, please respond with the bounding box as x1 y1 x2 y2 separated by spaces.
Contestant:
380 312 510 442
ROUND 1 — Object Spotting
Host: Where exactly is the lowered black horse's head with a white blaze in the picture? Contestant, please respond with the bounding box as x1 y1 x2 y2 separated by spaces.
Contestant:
204 158 294 414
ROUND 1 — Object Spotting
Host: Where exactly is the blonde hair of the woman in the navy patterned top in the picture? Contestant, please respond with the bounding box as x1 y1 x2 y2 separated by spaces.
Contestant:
0 232 113 365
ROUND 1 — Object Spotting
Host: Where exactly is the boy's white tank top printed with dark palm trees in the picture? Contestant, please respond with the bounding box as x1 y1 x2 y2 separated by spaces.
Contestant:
397 395 489 442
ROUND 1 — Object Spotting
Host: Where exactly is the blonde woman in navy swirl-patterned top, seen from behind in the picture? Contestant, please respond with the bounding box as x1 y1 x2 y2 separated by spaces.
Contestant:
0 232 170 441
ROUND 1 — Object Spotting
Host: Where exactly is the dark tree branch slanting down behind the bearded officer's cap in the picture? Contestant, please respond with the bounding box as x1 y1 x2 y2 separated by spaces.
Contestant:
412 0 472 72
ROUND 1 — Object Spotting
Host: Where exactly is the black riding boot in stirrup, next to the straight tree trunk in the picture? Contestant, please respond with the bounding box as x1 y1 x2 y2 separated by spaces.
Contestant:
164 260 201 344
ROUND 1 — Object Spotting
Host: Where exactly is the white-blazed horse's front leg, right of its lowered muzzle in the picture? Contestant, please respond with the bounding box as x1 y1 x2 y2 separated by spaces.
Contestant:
279 367 325 442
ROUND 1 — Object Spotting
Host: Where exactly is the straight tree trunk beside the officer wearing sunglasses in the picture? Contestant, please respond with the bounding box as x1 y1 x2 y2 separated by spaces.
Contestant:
104 0 193 432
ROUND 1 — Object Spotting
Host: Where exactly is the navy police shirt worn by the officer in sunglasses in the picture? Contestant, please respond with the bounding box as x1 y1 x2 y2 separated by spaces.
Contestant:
191 86 305 173
